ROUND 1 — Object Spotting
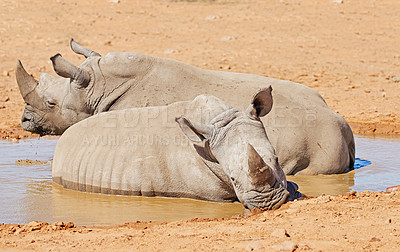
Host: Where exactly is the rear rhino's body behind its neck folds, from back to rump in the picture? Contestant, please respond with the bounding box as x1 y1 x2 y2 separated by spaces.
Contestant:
99 54 355 174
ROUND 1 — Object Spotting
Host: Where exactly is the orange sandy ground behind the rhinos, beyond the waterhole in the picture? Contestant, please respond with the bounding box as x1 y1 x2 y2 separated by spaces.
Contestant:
0 0 400 138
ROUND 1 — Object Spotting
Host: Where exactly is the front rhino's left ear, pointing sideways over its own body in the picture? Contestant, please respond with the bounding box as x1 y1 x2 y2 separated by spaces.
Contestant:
175 116 218 163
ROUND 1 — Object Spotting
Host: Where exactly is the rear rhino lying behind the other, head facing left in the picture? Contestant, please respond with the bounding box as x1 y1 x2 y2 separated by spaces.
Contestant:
16 40 355 174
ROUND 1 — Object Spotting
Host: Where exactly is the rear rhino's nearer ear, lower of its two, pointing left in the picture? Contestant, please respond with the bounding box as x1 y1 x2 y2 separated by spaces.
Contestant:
50 53 90 87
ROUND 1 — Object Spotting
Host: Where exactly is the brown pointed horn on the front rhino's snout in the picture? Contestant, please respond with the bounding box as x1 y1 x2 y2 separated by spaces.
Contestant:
247 144 276 186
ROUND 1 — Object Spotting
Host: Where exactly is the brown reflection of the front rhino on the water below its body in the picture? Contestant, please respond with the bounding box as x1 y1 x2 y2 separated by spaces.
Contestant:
51 183 243 225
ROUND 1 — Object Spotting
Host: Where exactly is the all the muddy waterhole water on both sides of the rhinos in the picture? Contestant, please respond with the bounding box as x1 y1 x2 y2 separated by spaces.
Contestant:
0 137 400 225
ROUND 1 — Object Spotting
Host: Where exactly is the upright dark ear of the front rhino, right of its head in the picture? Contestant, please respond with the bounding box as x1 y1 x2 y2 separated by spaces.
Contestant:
247 86 273 118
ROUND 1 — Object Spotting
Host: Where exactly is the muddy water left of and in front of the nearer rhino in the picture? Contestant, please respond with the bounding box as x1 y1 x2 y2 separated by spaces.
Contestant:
0 138 243 225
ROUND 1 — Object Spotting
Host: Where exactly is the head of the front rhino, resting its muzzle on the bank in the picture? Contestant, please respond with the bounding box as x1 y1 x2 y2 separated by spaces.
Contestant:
176 87 290 209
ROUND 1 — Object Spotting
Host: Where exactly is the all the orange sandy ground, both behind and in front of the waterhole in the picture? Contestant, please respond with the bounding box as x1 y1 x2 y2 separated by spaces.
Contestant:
0 0 400 251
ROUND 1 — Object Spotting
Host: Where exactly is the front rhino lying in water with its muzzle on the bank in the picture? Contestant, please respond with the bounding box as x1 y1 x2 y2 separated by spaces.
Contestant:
52 87 298 209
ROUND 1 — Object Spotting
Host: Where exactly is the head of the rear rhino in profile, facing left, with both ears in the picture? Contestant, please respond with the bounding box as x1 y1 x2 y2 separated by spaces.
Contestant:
16 40 100 135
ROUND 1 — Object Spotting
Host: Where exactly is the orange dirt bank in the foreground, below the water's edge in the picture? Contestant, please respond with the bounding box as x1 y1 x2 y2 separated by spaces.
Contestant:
0 191 400 251
